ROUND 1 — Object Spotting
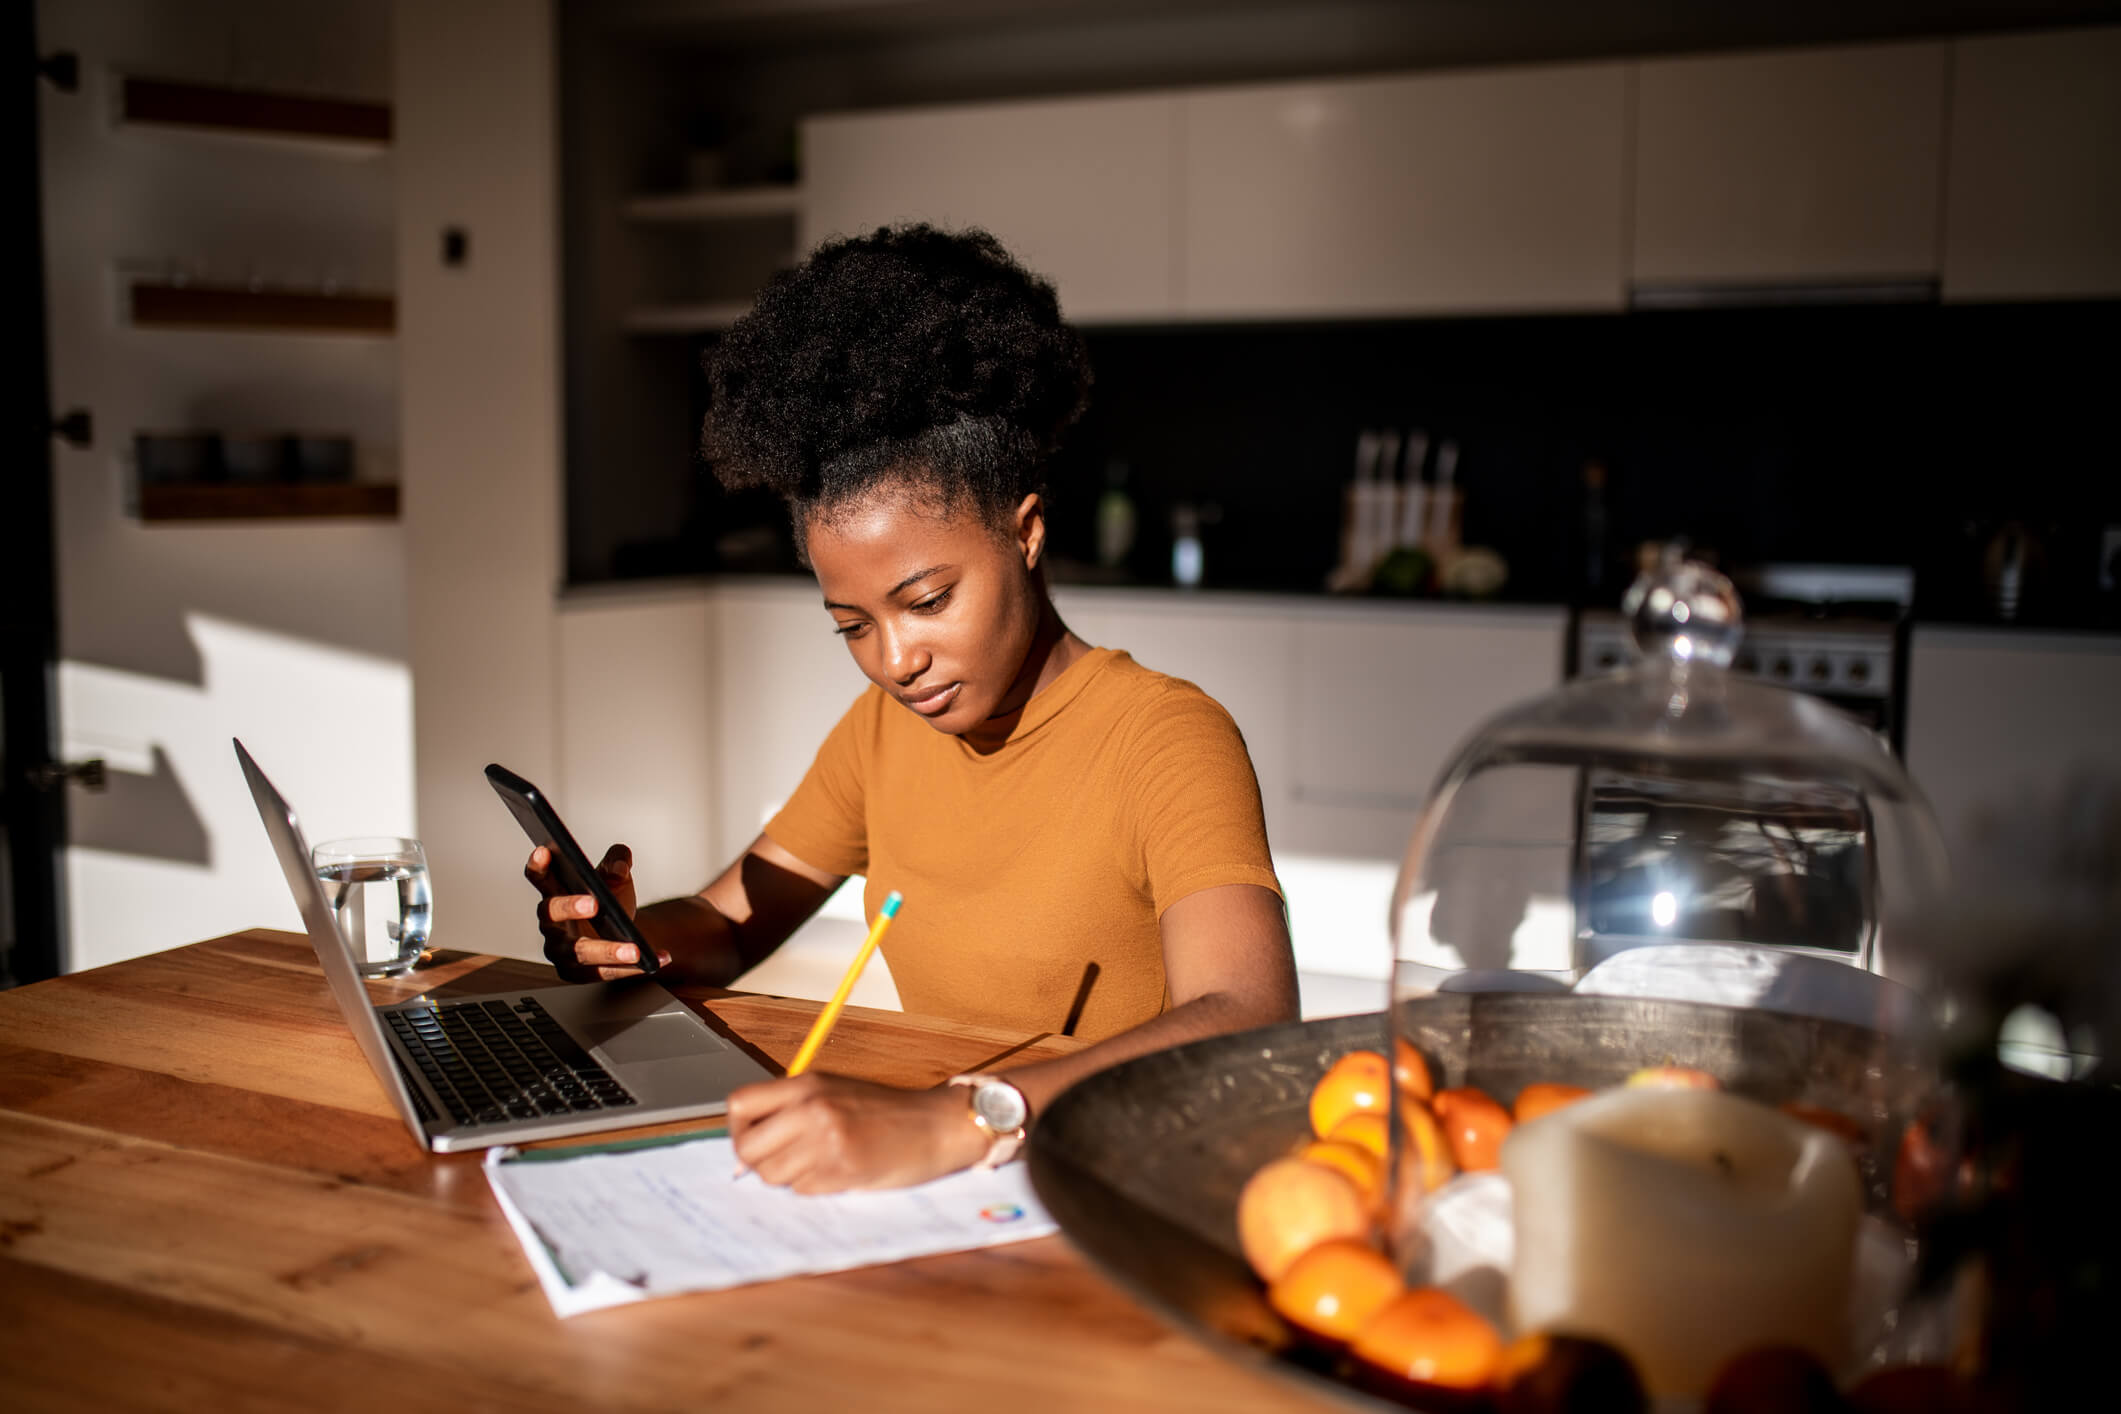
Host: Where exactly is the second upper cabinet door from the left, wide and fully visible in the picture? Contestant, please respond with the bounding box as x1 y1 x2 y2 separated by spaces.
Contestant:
1181 64 1627 318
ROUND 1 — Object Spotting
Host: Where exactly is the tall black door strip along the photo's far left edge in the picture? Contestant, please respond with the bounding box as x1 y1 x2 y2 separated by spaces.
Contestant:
0 0 76 986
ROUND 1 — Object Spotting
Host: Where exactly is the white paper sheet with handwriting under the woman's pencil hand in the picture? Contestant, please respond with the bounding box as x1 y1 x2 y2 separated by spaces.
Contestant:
486 1136 1056 1316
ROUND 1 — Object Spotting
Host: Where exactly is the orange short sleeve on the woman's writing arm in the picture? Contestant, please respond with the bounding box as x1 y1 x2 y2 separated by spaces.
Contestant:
1128 685 1281 916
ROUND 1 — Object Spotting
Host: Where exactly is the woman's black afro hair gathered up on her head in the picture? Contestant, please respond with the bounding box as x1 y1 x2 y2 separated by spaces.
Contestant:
702 225 1090 522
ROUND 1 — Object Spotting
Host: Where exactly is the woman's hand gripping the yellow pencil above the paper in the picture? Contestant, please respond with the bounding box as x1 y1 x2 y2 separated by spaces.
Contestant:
730 1073 986 1194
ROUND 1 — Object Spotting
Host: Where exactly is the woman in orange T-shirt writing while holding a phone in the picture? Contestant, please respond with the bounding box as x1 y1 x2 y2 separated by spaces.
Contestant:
528 227 1296 1194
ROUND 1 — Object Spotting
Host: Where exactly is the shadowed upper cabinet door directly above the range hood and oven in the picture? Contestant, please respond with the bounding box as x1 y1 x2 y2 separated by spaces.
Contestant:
1633 42 1947 282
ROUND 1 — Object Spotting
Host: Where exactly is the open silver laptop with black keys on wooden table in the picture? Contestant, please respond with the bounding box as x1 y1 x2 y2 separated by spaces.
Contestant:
235 742 768 1153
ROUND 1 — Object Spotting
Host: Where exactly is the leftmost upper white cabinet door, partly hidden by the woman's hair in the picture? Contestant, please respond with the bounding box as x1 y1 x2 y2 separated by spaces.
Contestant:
802 98 1177 320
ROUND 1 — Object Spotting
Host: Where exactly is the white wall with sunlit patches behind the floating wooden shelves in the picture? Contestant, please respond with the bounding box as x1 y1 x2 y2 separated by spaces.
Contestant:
38 0 414 969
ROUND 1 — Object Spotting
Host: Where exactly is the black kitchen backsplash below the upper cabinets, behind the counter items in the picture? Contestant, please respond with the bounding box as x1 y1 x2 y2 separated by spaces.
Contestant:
568 301 2121 623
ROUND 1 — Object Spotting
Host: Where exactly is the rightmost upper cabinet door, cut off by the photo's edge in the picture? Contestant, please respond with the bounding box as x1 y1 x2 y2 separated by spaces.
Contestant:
1945 25 2121 299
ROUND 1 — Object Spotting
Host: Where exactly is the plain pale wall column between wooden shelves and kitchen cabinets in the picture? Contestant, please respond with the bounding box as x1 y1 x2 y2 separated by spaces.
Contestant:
395 0 560 952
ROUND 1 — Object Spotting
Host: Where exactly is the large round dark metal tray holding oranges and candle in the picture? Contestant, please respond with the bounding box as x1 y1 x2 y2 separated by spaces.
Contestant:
1027 992 1934 1410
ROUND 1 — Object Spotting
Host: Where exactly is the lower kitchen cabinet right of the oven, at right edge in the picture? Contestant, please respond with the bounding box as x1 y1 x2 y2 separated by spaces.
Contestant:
1907 628 2121 869
